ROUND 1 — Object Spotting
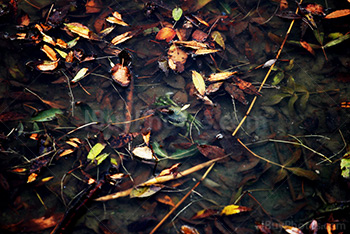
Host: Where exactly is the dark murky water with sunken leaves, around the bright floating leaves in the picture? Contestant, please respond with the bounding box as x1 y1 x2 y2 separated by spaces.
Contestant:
0 1 350 233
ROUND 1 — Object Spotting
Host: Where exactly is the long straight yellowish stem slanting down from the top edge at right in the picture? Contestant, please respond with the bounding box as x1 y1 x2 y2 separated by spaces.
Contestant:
232 0 303 136
